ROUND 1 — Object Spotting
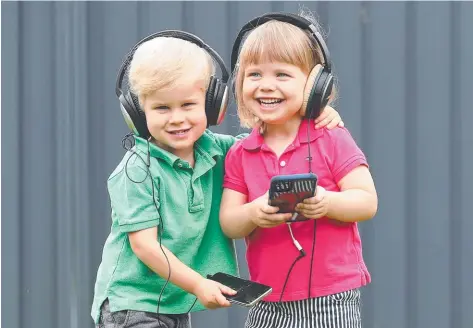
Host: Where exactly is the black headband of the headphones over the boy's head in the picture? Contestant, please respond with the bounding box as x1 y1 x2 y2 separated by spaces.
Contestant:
115 30 230 97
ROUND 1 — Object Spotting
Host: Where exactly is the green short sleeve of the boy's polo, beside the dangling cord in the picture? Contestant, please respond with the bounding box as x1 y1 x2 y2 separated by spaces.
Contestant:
107 160 160 232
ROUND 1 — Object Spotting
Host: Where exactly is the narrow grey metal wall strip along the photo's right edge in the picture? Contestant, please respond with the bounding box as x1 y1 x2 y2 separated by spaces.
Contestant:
456 2 473 327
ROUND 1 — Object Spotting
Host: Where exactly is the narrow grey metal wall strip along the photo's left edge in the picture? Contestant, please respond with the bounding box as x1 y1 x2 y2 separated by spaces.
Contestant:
1 2 24 327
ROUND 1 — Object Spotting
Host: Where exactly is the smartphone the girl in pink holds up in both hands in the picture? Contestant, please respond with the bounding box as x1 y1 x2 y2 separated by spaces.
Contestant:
269 173 317 222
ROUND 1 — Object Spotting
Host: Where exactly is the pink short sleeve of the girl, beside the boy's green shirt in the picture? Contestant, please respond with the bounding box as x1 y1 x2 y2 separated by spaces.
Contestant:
223 142 248 195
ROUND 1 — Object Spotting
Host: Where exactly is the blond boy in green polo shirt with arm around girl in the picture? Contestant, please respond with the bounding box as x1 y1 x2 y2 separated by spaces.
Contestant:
91 31 340 328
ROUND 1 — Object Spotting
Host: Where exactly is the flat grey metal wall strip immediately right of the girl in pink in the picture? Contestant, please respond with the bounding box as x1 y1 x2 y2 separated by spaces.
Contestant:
360 2 409 328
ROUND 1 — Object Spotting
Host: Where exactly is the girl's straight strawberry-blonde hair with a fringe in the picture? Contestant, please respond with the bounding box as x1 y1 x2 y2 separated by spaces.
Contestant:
233 11 336 129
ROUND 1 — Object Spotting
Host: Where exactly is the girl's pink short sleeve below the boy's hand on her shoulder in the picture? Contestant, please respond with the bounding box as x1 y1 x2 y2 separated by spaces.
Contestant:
326 127 368 184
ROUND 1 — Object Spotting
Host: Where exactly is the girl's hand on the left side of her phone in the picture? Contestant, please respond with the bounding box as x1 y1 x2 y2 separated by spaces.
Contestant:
251 192 292 228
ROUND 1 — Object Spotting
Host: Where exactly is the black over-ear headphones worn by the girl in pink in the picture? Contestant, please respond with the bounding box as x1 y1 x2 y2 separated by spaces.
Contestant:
231 13 333 118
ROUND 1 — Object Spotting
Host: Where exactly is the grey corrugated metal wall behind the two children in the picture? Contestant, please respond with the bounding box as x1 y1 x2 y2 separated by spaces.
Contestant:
1 1 473 328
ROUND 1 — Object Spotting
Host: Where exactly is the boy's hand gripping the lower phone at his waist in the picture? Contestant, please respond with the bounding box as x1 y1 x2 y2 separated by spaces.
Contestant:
194 279 236 309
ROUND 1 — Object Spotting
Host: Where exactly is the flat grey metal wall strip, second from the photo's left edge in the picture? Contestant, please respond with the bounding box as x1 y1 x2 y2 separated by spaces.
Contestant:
18 3 56 327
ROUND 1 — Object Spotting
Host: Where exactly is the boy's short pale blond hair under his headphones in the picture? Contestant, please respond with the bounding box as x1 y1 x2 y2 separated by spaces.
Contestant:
128 37 215 104
